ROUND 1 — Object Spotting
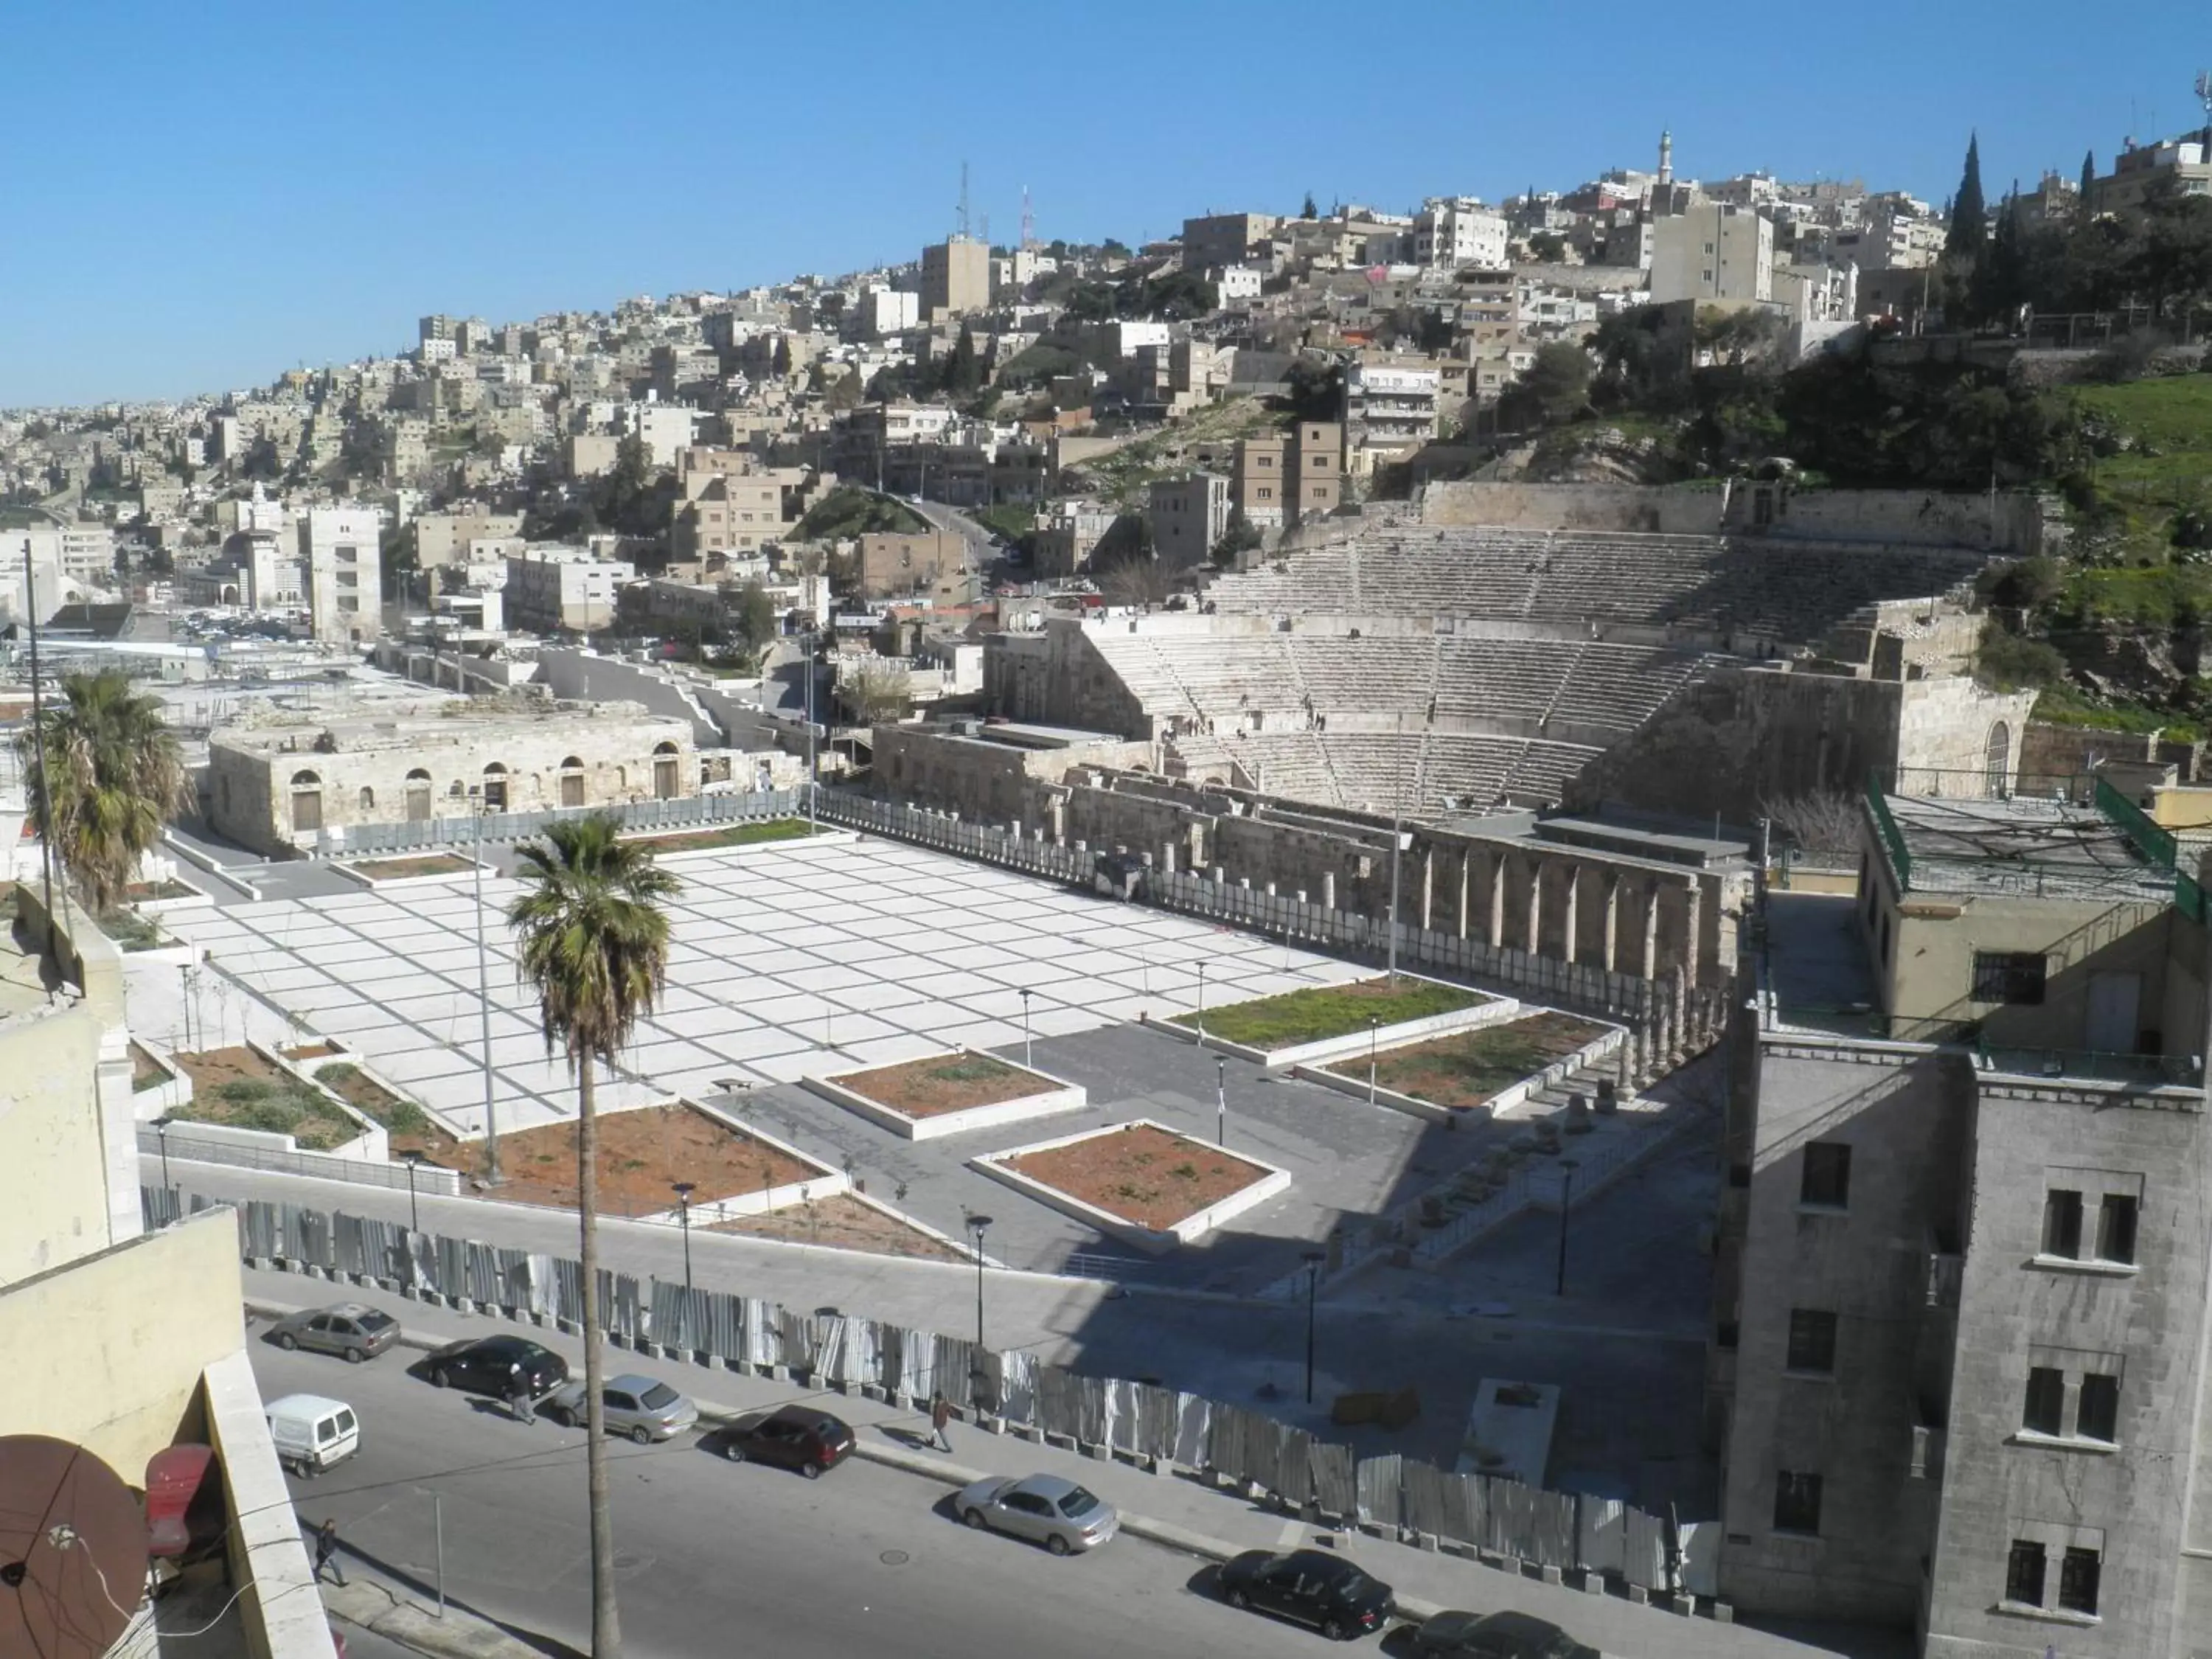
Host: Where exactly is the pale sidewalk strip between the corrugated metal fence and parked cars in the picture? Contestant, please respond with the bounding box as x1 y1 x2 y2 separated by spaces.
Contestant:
246 1272 1889 1659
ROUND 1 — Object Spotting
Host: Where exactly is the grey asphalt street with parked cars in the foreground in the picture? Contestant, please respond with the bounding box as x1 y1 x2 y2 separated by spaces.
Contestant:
252 1340 1334 1659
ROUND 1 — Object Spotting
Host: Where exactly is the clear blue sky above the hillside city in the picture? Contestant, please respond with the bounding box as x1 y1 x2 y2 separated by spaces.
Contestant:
0 0 2212 407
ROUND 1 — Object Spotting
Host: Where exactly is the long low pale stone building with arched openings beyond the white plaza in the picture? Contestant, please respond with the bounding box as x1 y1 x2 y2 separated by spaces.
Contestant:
206 701 699 856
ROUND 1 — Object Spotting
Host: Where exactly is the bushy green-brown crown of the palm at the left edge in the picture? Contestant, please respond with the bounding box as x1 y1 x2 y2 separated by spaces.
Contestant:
15 668 192 916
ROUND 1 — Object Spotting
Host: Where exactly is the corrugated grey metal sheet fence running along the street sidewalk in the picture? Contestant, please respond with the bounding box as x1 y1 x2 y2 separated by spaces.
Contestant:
190 1188 1717 1597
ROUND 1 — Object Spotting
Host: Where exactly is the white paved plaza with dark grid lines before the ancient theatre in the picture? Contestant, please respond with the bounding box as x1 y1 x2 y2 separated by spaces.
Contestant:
133 834 1360 1135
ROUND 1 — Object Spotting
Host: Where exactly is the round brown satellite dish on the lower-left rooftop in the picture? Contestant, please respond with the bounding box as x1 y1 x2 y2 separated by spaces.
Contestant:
0 1433 146 1659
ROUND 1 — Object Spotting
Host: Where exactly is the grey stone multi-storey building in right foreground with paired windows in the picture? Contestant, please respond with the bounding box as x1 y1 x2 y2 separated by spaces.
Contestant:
1708 787 2212 1659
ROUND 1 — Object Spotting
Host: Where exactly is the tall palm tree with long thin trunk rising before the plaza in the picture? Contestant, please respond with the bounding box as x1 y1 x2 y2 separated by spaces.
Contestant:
507 812 679 1659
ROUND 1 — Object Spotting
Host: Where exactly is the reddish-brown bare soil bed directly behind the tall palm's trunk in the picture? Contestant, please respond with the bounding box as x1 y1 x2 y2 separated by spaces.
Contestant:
392 1106 823 1214
